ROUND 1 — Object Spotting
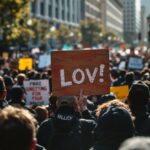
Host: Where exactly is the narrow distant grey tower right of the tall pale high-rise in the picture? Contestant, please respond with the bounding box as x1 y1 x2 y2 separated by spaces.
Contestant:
140 6 148 42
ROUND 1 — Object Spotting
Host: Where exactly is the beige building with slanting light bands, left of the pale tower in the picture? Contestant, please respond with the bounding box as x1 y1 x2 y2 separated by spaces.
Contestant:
101 0 123 37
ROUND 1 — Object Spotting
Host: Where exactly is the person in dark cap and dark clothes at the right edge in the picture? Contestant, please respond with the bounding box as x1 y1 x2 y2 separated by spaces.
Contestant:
127 81 150 135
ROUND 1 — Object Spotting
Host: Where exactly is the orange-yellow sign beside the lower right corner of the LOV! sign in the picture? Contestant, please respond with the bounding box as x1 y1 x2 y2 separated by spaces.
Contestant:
110 85 129 100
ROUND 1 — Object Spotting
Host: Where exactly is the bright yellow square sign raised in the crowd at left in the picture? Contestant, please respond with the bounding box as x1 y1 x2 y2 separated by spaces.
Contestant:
19 58 32 71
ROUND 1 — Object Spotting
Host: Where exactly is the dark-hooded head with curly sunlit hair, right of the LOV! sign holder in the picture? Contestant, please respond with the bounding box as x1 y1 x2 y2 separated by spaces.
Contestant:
95 100 135 146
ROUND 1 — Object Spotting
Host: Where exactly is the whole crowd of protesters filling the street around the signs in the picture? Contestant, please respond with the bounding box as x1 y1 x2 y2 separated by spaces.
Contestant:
0 48 150 150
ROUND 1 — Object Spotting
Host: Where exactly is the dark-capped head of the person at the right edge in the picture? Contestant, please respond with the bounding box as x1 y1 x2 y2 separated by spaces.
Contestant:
128 81 150 106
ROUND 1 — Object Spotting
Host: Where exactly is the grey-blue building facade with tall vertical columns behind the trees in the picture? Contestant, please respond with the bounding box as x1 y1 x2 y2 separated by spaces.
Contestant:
31 0 81 26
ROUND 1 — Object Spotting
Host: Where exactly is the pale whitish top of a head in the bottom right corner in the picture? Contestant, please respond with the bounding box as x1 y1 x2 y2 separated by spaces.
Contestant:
119 137 150 150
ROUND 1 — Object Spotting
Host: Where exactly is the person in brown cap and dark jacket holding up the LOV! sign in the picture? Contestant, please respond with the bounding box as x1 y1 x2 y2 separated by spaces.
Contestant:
37 96 95 150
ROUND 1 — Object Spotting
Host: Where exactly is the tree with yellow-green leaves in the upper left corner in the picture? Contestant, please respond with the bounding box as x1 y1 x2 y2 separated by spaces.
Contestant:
0 0 33 48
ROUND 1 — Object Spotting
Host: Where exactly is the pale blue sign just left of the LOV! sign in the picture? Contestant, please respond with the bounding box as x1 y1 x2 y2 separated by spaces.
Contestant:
38 54 51 68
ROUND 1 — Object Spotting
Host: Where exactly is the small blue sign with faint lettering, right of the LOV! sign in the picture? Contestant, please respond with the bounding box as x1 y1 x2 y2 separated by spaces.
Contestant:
128 57 143 70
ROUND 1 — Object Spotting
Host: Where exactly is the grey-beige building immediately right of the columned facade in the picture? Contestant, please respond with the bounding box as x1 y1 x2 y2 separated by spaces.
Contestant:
81 0 101 21
